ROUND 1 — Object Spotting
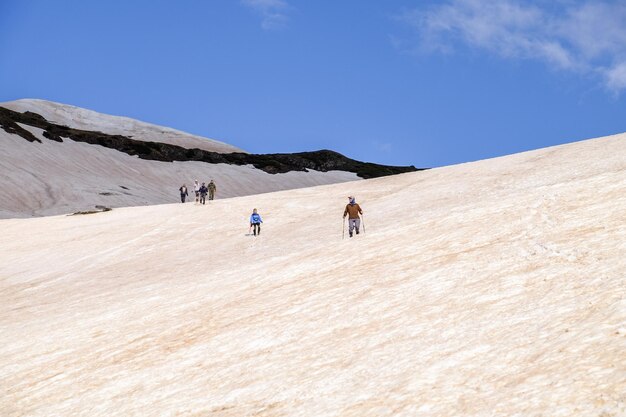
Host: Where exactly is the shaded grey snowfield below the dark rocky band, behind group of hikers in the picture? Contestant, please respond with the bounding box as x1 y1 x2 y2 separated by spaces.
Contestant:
0 109 360 218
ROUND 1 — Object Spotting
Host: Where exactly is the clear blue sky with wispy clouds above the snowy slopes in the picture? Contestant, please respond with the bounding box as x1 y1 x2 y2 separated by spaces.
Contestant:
0 0 626 167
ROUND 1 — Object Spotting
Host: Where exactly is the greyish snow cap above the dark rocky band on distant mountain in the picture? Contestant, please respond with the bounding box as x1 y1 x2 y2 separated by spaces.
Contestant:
0 99 244 153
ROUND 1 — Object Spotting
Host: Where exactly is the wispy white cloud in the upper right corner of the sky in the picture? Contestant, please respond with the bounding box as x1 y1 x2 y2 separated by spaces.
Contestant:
396 0 626 93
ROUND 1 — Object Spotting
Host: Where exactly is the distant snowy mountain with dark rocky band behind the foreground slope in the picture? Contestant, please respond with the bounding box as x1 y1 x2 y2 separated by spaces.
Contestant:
0 100 415 218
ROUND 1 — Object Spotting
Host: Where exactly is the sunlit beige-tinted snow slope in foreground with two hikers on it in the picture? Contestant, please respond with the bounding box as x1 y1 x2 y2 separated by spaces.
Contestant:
0 135 626 417
